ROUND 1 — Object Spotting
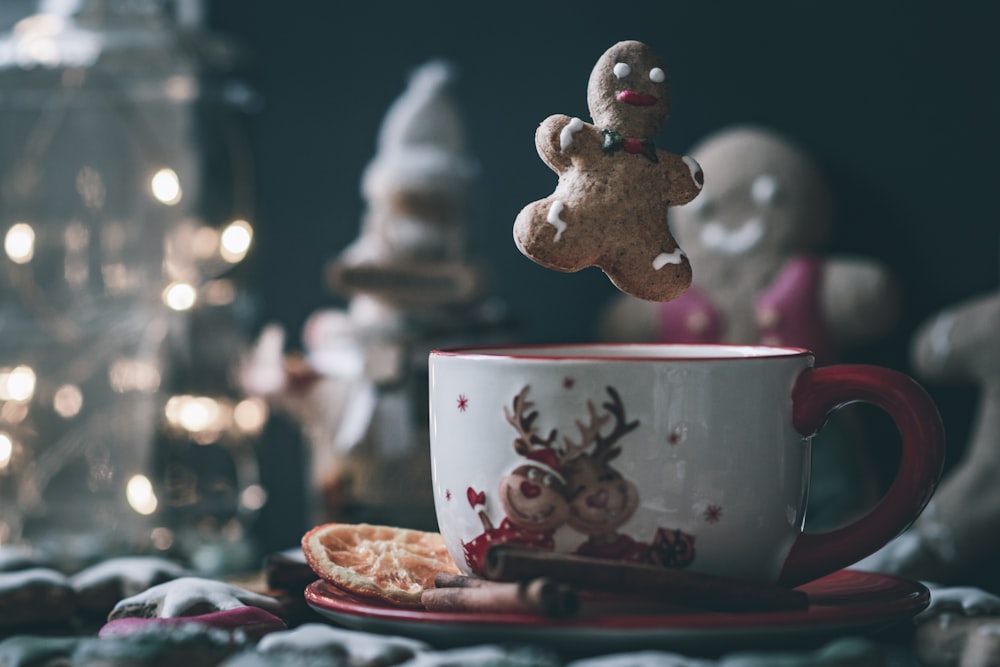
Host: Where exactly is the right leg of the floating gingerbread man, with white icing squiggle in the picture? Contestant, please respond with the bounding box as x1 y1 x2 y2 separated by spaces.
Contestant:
600 233 691 301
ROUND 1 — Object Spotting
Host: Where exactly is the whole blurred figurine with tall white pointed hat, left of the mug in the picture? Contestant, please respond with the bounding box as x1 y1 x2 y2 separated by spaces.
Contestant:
242 61 503 529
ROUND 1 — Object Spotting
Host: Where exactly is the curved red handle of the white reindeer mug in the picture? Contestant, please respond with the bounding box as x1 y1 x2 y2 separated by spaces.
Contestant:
778 364 944 586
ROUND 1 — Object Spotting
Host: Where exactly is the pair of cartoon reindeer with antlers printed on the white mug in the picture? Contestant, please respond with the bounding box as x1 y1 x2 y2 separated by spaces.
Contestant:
462 386 694 572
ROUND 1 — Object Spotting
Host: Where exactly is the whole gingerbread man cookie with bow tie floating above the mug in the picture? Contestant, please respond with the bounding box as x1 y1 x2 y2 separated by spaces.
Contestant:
514 41 704 301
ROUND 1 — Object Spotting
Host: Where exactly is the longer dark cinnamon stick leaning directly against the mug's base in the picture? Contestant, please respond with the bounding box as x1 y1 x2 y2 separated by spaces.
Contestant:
483 544 809 612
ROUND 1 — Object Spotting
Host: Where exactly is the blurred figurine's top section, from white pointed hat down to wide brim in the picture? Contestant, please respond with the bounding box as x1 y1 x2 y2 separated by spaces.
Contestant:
328 61 483 308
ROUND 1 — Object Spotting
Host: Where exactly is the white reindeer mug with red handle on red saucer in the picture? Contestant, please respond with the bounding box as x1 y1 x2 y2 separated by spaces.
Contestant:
430 344 944 585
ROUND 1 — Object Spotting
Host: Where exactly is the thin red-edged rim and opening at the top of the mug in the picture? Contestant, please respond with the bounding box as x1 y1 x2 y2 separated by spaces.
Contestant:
430 343 813 362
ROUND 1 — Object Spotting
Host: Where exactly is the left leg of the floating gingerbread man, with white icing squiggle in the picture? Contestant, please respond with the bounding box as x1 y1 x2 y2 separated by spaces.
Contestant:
514 197 600 272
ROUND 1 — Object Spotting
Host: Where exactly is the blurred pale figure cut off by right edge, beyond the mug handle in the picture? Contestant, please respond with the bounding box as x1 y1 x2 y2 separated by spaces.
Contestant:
860 272 1000 592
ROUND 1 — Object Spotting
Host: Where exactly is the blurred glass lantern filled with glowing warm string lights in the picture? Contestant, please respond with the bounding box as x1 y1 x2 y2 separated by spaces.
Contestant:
0 0 267 555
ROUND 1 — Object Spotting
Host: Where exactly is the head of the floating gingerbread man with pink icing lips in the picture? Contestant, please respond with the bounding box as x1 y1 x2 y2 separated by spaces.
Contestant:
587 42 670 139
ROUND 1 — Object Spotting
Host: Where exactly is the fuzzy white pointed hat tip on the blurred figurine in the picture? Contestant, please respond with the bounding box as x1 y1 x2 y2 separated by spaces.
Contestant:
361 60 478 199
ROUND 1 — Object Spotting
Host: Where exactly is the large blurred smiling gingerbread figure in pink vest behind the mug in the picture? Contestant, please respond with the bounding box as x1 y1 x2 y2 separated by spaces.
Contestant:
601 126 897 528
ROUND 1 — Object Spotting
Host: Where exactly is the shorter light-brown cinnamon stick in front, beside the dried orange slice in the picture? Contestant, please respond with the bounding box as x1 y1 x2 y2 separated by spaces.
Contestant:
420 573 579 618
